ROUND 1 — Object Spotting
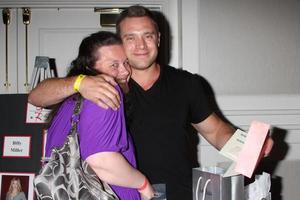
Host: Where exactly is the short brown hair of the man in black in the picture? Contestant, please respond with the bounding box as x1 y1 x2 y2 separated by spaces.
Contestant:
116 5 159 36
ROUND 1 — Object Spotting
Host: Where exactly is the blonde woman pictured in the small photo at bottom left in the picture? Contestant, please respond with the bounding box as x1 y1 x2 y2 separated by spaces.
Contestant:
6 177 26 200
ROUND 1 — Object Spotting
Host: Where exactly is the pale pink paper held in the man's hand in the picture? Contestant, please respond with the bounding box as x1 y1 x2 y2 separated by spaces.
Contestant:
235 121 270 178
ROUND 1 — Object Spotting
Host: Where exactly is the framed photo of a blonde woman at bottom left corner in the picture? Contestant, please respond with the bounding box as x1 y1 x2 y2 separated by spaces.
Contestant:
0 172 34 200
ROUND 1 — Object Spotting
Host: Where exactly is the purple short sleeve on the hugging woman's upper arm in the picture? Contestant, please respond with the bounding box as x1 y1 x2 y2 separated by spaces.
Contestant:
78 100 128 160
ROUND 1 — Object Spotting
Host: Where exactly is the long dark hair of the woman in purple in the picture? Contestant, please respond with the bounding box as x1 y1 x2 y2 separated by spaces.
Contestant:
47 31 122 123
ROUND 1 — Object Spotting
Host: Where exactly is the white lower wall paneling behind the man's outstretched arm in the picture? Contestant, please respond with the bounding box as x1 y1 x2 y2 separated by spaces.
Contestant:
198 95 300 200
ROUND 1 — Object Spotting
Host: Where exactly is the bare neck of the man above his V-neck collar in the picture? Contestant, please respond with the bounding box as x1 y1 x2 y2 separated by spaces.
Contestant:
131 63 160 90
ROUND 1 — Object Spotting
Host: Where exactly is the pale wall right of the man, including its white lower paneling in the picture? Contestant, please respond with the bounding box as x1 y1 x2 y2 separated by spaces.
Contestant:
182 0 300 200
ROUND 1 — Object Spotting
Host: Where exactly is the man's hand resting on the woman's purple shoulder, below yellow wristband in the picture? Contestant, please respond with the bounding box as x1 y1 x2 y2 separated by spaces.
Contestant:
79 74 120 110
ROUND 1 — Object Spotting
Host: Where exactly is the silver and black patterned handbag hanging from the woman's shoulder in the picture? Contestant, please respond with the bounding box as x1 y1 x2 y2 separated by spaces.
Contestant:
33 96 119 200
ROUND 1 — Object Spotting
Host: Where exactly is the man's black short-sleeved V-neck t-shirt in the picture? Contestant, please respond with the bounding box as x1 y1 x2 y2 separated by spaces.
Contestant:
126 66 212 200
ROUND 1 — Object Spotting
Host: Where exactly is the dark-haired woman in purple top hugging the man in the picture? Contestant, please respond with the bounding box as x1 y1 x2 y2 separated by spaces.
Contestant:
46 31 153 200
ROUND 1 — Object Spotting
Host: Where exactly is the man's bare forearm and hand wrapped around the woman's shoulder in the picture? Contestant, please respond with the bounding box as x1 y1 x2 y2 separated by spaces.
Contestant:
28 74 120 109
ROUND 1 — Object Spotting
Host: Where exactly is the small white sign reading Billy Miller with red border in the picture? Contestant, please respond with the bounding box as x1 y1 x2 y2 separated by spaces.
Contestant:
2 135 31 158
